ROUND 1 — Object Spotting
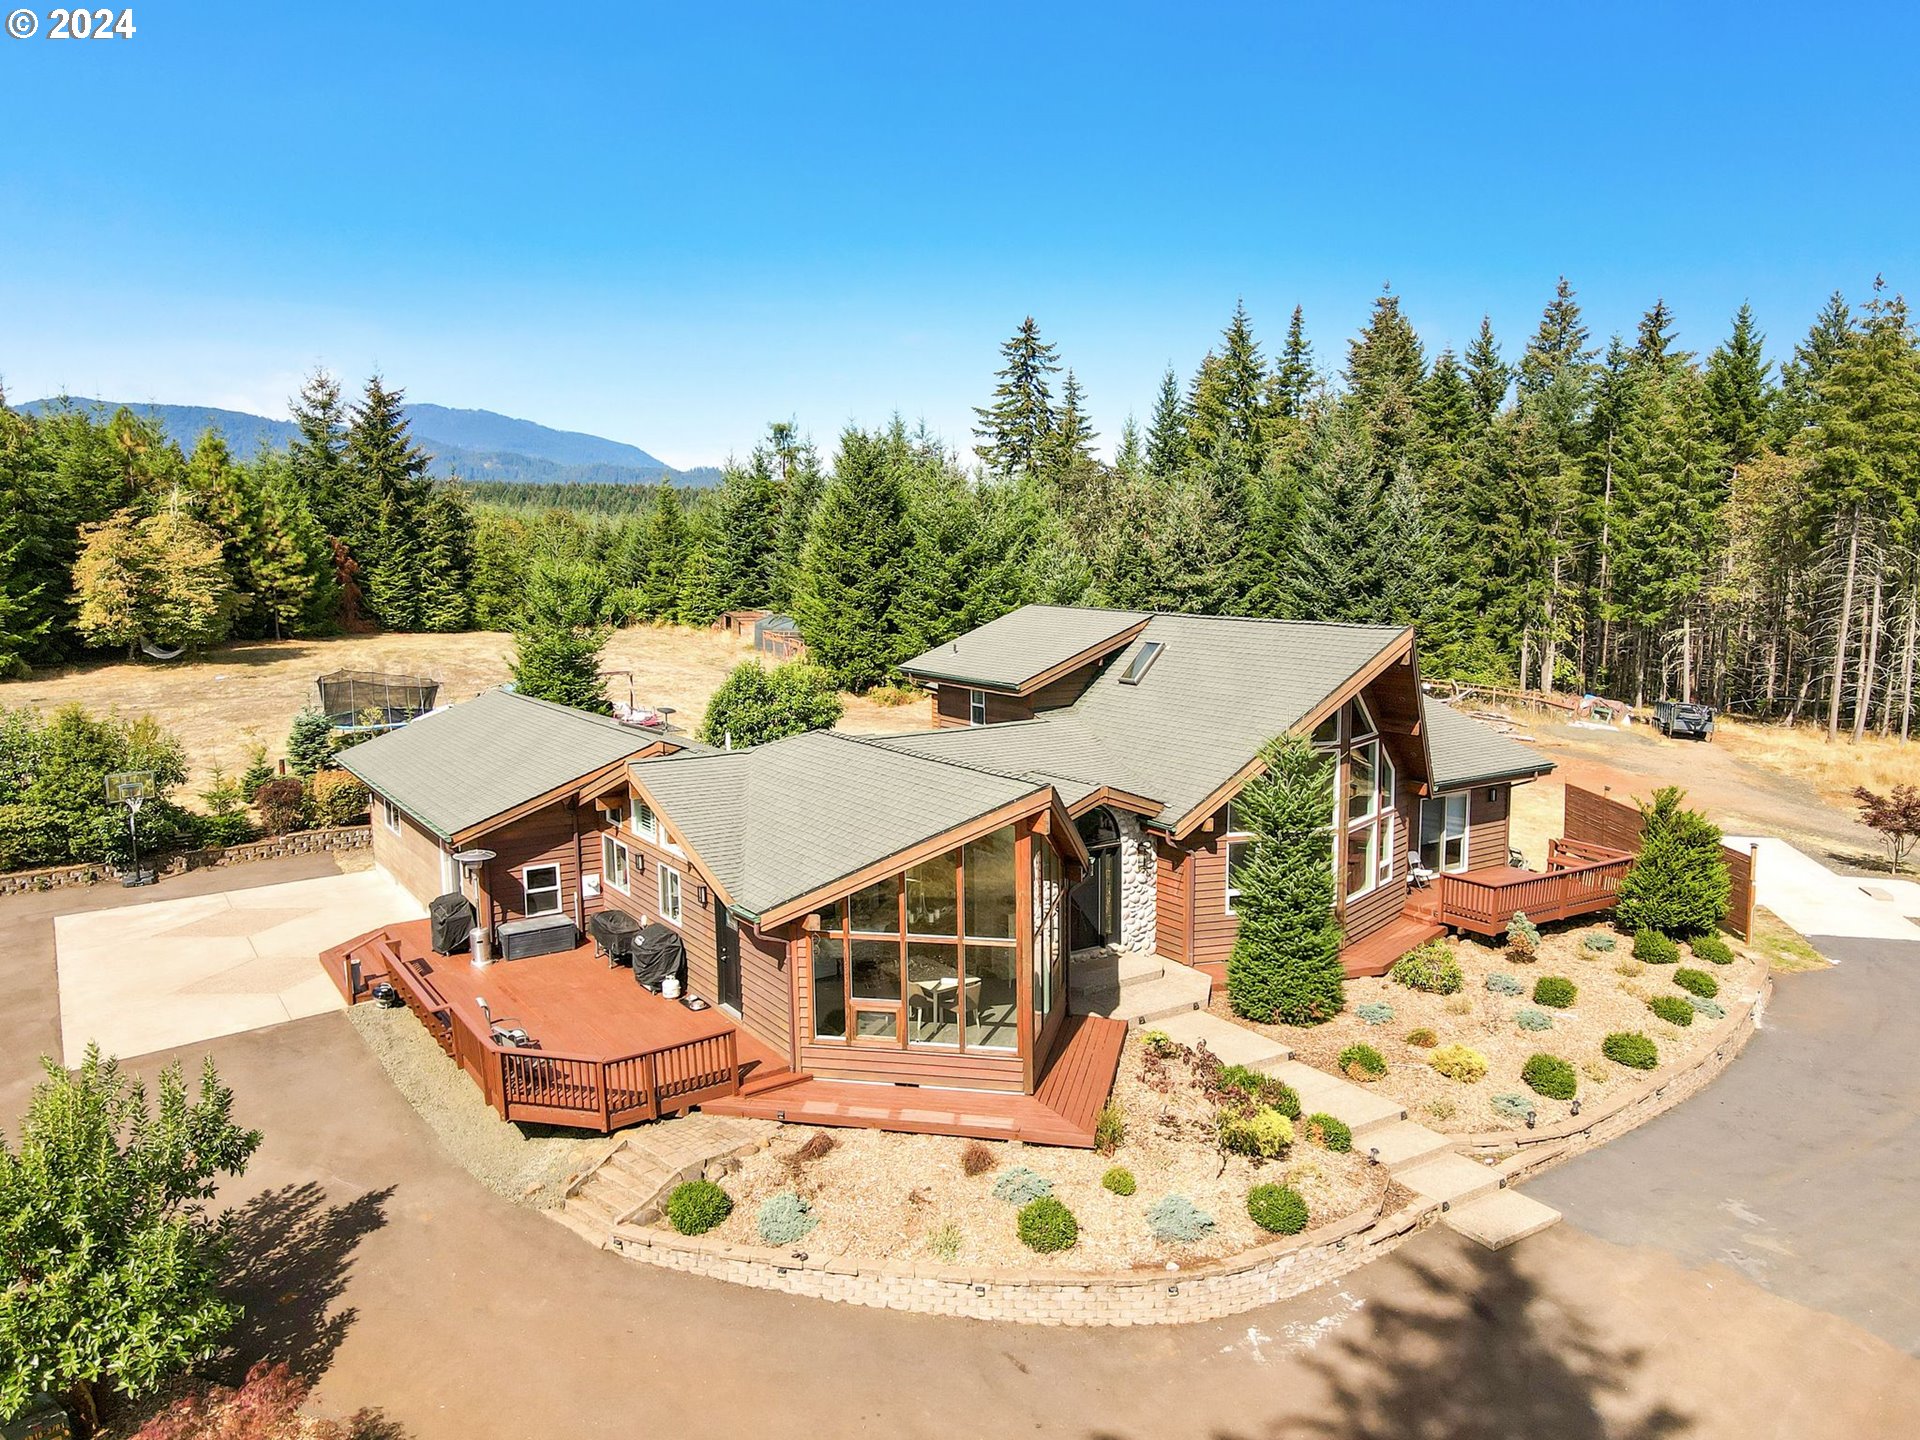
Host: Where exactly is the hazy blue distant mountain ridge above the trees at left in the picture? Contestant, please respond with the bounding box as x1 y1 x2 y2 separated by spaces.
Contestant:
19 396 720 486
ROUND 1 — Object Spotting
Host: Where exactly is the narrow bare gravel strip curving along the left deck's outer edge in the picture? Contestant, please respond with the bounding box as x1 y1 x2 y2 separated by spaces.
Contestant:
348 1004 611 1210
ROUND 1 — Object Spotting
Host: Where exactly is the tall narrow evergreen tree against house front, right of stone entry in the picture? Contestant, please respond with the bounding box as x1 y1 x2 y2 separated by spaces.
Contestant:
1227 735 1346 1025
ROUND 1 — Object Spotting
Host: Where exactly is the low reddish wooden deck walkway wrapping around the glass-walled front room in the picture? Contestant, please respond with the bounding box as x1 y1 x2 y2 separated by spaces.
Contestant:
703 1016 1127 1150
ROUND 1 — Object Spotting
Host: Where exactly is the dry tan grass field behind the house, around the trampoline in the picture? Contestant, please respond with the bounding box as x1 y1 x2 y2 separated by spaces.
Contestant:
0 626 933 791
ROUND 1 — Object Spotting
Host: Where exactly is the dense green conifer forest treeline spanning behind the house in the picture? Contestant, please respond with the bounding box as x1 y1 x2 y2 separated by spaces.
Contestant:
0 280 1920 733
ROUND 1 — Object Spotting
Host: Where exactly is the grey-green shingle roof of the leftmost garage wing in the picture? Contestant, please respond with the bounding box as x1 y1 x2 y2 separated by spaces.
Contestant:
340 689 659 839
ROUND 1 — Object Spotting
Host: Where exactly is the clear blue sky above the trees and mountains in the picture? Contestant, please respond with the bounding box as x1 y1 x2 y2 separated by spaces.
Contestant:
0 0 1920 465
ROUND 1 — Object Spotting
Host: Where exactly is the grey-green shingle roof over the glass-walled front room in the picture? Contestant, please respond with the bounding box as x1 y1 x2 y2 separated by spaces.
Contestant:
632 732 1046 916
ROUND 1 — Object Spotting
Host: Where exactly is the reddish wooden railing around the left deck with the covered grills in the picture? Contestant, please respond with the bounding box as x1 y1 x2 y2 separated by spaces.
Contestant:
372 937 739 1133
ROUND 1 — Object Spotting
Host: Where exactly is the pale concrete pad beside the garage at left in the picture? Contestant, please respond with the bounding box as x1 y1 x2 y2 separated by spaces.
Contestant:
54 870 424 1066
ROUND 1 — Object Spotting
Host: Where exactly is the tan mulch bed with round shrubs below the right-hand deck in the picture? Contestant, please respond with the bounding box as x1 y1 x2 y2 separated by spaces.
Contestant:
1213 924 1764 1135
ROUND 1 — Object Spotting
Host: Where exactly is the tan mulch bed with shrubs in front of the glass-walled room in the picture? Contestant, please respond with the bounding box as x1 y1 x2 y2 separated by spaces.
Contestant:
675 1041 1388 1271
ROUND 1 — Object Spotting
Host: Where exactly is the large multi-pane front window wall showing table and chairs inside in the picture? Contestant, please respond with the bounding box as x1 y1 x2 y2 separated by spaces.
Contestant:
812 826 1021 1050
